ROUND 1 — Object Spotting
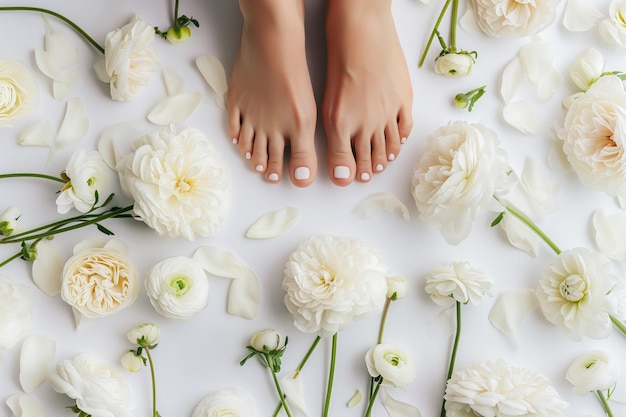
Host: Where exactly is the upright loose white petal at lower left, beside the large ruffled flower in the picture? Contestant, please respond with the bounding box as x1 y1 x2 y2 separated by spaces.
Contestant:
20 335 56 393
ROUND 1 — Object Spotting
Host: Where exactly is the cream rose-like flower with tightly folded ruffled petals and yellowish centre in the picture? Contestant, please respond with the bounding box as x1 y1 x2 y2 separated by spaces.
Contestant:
61 239 139 317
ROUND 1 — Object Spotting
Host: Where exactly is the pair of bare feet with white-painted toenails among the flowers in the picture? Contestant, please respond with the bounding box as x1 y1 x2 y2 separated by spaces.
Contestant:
227 0 413 187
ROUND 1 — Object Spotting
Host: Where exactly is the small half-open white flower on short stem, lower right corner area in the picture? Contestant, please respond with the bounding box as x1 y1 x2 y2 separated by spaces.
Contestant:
565 349 620 395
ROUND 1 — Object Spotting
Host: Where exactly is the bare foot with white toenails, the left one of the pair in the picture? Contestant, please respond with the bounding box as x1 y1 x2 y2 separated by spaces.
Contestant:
227 0 317 187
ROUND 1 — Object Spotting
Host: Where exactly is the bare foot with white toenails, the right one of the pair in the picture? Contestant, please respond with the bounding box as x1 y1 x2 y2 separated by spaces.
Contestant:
322 0 413 186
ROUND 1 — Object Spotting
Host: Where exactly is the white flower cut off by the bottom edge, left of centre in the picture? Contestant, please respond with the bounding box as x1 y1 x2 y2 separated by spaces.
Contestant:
191 389 260 417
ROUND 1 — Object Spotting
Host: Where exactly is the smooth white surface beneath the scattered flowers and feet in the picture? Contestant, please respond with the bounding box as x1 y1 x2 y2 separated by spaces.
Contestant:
0 0 626 417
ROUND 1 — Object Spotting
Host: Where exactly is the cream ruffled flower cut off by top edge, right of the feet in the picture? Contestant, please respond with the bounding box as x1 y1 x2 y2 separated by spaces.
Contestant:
472 0 560 37
